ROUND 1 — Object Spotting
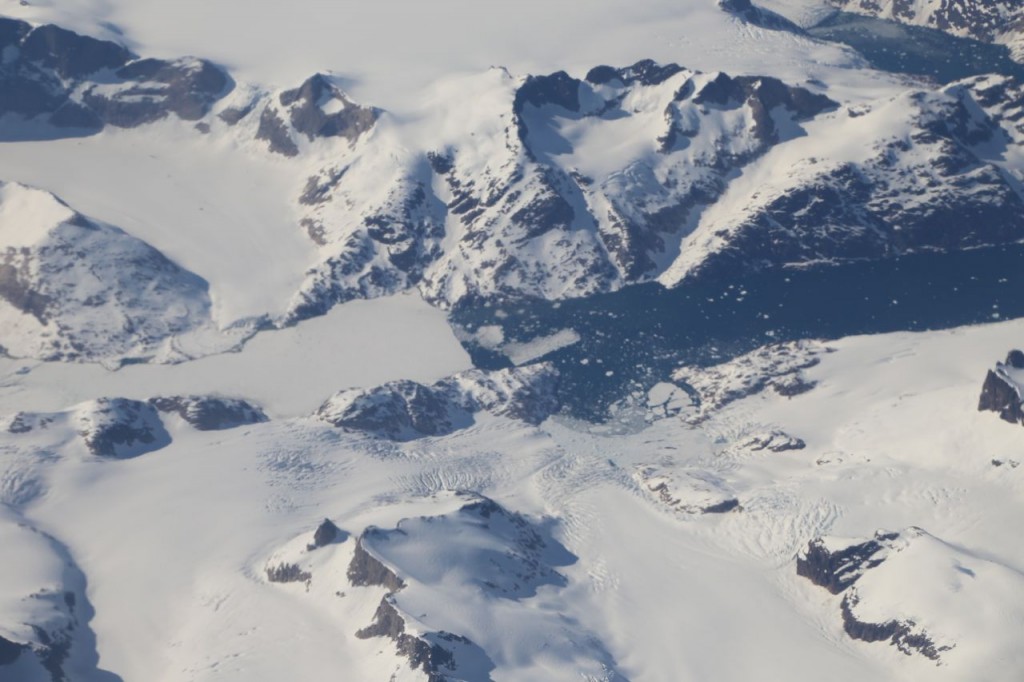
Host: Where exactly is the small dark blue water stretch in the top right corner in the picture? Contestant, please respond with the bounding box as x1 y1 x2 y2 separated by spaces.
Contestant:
808 12 1024 83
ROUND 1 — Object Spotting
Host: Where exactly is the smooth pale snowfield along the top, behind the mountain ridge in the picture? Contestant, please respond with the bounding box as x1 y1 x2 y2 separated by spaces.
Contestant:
0 0 864 112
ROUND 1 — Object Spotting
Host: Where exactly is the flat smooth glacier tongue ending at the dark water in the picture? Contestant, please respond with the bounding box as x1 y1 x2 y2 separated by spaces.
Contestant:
0 295 470 417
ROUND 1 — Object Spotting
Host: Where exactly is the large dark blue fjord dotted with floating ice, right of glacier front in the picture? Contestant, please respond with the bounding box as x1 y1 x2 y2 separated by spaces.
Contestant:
452 245 1024 421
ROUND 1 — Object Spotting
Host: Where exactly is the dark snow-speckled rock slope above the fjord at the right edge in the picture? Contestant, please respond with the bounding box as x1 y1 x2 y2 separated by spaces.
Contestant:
690 79 1024 279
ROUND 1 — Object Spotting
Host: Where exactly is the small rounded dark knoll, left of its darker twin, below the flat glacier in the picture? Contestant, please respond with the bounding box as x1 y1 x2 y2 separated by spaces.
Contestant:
77 398 171 458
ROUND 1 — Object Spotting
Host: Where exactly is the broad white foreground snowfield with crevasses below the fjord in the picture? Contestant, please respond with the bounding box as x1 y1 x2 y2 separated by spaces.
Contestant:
6 315 1024 682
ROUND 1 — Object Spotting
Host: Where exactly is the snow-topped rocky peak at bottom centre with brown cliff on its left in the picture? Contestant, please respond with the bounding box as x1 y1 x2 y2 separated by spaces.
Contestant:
348 493 623 682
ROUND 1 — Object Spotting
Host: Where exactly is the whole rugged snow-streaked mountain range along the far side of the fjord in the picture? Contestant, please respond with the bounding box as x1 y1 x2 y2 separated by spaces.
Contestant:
5 13 1024 327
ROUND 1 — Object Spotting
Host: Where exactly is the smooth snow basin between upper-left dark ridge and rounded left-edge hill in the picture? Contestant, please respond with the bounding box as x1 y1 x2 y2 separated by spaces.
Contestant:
0 120 315 327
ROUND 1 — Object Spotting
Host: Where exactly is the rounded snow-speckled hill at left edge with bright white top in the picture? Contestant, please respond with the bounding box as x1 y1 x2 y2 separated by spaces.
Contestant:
0 182 218 363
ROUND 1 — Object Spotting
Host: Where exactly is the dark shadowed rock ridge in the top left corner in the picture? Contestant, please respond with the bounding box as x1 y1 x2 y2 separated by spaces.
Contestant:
0 19 232 134
